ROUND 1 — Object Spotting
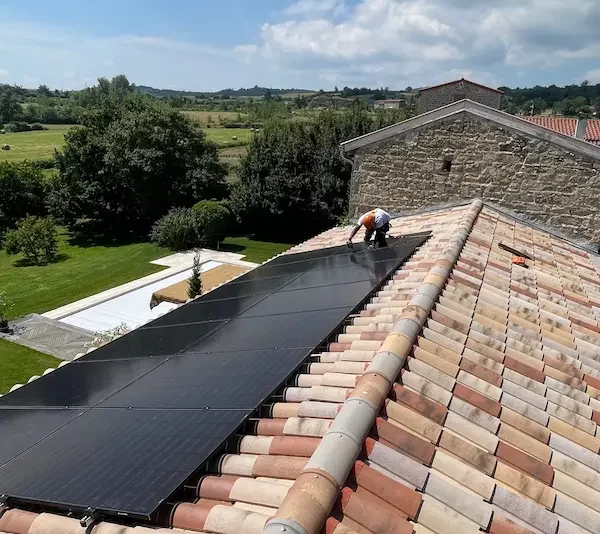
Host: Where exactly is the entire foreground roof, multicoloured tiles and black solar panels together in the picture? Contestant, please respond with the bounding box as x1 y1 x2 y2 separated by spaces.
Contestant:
5 200 600 534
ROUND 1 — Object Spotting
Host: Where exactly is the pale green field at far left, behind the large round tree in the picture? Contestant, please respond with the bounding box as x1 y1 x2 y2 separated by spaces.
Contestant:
0 125 73 161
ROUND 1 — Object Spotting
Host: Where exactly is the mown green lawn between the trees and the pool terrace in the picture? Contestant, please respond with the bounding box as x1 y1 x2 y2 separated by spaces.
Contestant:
0 228 170 320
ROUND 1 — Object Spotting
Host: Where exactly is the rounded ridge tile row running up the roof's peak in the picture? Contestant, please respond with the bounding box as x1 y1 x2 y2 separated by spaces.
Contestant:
263 199 483 534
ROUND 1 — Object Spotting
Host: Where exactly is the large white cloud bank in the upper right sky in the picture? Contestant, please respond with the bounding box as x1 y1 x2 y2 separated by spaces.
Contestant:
261 0 600 85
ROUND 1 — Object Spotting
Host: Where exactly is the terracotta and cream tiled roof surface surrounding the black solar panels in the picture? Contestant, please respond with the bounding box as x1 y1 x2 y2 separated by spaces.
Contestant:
0 201 600 534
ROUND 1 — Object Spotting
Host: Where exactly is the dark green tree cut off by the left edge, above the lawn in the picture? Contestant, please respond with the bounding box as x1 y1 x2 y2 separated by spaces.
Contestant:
0 161 46 220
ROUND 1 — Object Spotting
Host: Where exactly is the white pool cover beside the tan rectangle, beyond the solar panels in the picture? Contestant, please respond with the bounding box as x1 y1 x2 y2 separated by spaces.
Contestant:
61 261 221 332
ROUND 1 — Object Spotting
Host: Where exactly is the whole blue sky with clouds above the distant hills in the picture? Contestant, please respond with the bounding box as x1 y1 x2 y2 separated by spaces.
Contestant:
0 0 600 91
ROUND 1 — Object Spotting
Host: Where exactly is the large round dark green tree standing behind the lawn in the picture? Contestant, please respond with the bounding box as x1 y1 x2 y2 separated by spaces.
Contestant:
53 94 226 231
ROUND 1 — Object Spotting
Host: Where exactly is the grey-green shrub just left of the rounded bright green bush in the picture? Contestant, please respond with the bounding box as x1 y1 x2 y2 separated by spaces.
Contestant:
150 208 200 250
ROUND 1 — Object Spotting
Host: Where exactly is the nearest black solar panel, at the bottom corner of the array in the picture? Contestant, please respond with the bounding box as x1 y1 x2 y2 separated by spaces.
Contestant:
0 408 250 518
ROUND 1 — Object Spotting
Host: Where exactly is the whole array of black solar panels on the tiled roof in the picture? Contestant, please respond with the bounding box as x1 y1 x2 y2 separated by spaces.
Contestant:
0 234 427 519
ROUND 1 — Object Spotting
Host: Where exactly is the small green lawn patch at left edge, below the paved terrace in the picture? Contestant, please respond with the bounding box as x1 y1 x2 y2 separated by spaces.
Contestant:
0 339 60 395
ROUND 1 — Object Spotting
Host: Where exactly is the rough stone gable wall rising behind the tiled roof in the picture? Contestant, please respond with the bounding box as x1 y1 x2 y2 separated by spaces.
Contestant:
350 117 600 243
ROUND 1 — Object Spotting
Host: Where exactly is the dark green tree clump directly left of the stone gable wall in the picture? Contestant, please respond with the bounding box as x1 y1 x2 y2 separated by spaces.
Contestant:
231 103 393 242
